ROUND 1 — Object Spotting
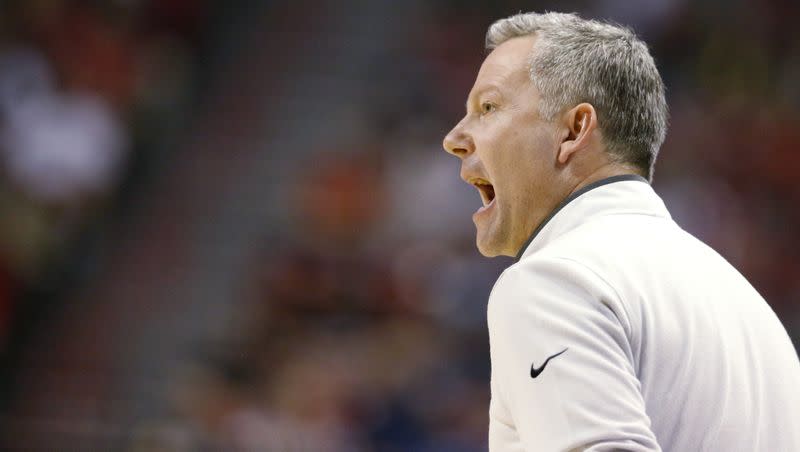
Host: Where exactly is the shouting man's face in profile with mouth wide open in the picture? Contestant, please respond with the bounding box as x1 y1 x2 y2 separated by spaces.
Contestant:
444 36 566 257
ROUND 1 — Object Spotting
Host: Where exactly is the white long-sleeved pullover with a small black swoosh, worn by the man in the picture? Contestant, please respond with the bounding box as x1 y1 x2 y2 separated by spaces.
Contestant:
488 180 800 452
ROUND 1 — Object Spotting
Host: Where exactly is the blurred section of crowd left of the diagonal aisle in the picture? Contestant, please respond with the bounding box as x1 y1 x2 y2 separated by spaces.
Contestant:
0 0 202 350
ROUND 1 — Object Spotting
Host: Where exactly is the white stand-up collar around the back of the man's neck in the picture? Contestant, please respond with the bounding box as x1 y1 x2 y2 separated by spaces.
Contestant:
516 174 671 262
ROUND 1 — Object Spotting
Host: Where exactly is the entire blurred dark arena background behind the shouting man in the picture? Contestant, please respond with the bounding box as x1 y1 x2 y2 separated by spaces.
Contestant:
0 0 800 451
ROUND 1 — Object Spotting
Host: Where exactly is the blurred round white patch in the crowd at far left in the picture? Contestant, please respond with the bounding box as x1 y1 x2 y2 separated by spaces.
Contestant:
0 94 126 203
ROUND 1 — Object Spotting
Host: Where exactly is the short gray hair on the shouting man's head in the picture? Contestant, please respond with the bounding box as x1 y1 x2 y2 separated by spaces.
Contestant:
486 13 668 180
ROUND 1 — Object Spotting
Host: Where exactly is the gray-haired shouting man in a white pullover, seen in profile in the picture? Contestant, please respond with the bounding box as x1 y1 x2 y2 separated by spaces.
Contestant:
444 13 800 452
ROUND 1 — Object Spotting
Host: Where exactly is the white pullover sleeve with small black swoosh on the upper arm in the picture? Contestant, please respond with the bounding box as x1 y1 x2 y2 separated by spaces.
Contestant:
488 258 661 452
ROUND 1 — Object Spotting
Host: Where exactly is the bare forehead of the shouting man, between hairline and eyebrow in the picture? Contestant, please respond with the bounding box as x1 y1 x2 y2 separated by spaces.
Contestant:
472 35 536 93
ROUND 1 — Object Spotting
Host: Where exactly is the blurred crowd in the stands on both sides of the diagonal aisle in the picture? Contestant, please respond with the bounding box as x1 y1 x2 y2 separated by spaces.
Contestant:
0 0 800 451
